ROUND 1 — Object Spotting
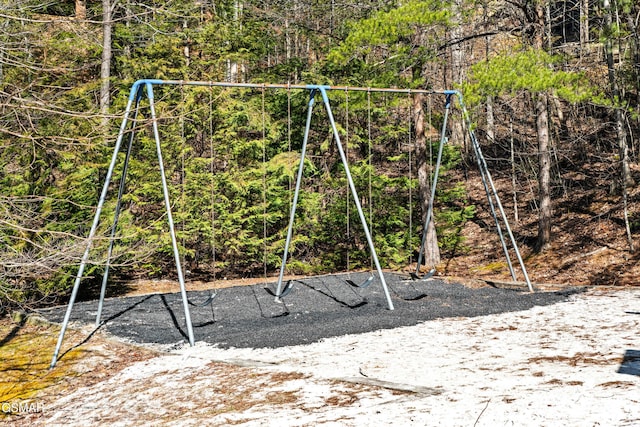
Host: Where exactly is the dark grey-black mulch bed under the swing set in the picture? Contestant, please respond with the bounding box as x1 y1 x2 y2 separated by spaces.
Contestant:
40 273 582 348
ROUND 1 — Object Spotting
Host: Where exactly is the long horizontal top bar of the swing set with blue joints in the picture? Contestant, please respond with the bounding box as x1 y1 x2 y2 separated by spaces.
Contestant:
129 79 462 101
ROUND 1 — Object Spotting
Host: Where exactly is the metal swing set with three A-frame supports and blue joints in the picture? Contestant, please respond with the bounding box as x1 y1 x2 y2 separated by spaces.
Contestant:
50 79 533 368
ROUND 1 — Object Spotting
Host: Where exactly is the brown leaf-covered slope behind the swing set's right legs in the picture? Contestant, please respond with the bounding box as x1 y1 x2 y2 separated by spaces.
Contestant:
438 165 640 287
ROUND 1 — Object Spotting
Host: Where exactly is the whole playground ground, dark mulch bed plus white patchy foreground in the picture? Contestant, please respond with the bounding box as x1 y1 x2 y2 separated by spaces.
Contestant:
31 275 640 426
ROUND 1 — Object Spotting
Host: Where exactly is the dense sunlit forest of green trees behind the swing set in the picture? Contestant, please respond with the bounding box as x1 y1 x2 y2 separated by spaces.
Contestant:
0 0 640 313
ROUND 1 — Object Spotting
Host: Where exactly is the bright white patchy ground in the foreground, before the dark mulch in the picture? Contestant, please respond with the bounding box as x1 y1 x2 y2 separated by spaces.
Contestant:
37 288 640 427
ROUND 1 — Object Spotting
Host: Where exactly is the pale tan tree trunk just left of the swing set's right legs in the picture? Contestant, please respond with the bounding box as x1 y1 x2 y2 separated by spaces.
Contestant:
413 93 440 267
